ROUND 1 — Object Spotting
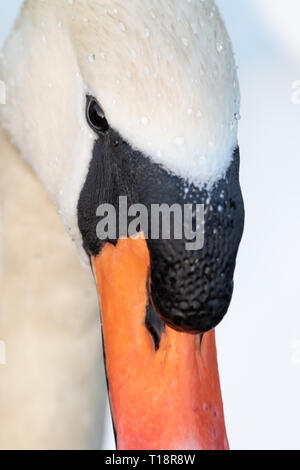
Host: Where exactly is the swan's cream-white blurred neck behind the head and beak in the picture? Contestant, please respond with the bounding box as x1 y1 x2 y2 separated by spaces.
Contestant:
0 127 106 449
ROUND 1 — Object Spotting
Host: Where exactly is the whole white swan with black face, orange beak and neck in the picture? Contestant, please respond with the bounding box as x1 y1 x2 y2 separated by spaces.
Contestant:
0 0 243 449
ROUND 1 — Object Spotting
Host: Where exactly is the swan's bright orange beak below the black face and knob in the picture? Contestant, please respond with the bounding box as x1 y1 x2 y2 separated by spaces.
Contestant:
92 237 228 450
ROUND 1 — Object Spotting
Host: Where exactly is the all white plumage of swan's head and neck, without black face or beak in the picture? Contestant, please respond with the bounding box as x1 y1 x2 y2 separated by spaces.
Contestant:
0 0 239 447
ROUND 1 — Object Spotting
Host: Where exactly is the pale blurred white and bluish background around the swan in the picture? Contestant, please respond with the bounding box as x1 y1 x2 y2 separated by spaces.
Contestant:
0 0 300 449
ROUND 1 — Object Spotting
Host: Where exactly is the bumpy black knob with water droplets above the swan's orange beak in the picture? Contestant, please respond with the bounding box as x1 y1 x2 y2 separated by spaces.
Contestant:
148 150 244 333
